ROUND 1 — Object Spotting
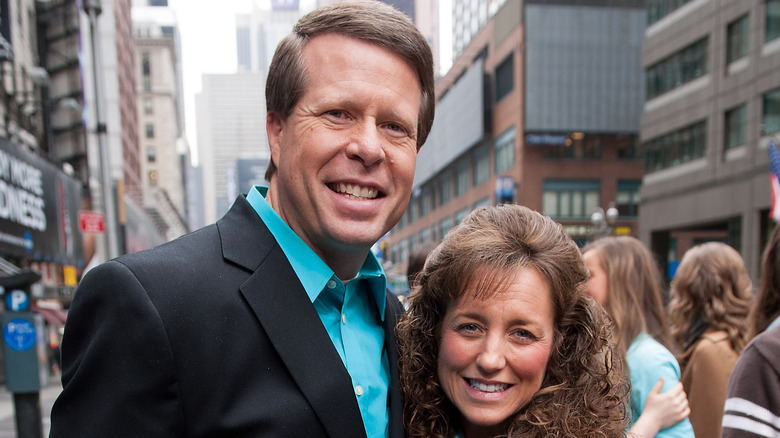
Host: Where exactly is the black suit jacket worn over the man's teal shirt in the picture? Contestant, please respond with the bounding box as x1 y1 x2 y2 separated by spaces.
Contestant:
50 197 403 438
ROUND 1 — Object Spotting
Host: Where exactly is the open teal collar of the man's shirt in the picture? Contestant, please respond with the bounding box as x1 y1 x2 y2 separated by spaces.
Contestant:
247 186 387 320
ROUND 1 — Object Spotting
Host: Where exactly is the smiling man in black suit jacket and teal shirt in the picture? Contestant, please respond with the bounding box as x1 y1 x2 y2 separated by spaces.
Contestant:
51 1 434 438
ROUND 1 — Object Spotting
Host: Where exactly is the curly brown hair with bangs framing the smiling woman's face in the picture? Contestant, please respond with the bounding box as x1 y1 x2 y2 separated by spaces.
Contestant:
396 205 629 438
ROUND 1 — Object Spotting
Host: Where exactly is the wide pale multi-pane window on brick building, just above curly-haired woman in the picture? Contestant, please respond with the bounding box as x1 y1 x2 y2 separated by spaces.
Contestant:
542 180 601 220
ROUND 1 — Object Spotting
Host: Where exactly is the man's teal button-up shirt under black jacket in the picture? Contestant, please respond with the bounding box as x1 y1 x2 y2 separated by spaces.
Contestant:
247 186 390 438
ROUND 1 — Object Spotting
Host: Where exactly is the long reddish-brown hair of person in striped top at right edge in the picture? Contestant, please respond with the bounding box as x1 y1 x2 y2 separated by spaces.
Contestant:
748 227 780 340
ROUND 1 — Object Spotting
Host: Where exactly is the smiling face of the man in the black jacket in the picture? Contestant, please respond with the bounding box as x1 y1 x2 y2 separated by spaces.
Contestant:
267 34 421 264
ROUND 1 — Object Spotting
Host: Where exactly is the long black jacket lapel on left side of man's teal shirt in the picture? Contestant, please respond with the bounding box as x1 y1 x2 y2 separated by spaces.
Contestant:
217 197 366 437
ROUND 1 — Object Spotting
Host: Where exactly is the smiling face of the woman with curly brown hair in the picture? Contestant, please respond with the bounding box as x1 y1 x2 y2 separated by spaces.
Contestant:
438 268 555 436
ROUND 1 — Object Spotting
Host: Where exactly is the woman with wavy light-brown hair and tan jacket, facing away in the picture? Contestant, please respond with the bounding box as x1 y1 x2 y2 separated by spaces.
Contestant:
669 242 753 437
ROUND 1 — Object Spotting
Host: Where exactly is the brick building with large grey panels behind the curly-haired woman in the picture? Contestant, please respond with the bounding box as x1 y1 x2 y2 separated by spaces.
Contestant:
384 0 646 280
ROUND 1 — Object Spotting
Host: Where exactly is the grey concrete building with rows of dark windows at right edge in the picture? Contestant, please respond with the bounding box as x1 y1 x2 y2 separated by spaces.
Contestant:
639 0 780 279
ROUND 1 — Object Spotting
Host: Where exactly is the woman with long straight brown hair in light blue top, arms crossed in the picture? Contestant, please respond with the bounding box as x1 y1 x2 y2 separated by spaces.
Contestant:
583 236 694 437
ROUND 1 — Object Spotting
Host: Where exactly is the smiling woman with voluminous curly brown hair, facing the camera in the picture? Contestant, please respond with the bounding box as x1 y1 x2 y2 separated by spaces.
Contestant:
397 205 628 438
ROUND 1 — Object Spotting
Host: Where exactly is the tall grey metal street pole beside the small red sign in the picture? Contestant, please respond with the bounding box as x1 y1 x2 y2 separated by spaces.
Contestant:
84 0 119 259
